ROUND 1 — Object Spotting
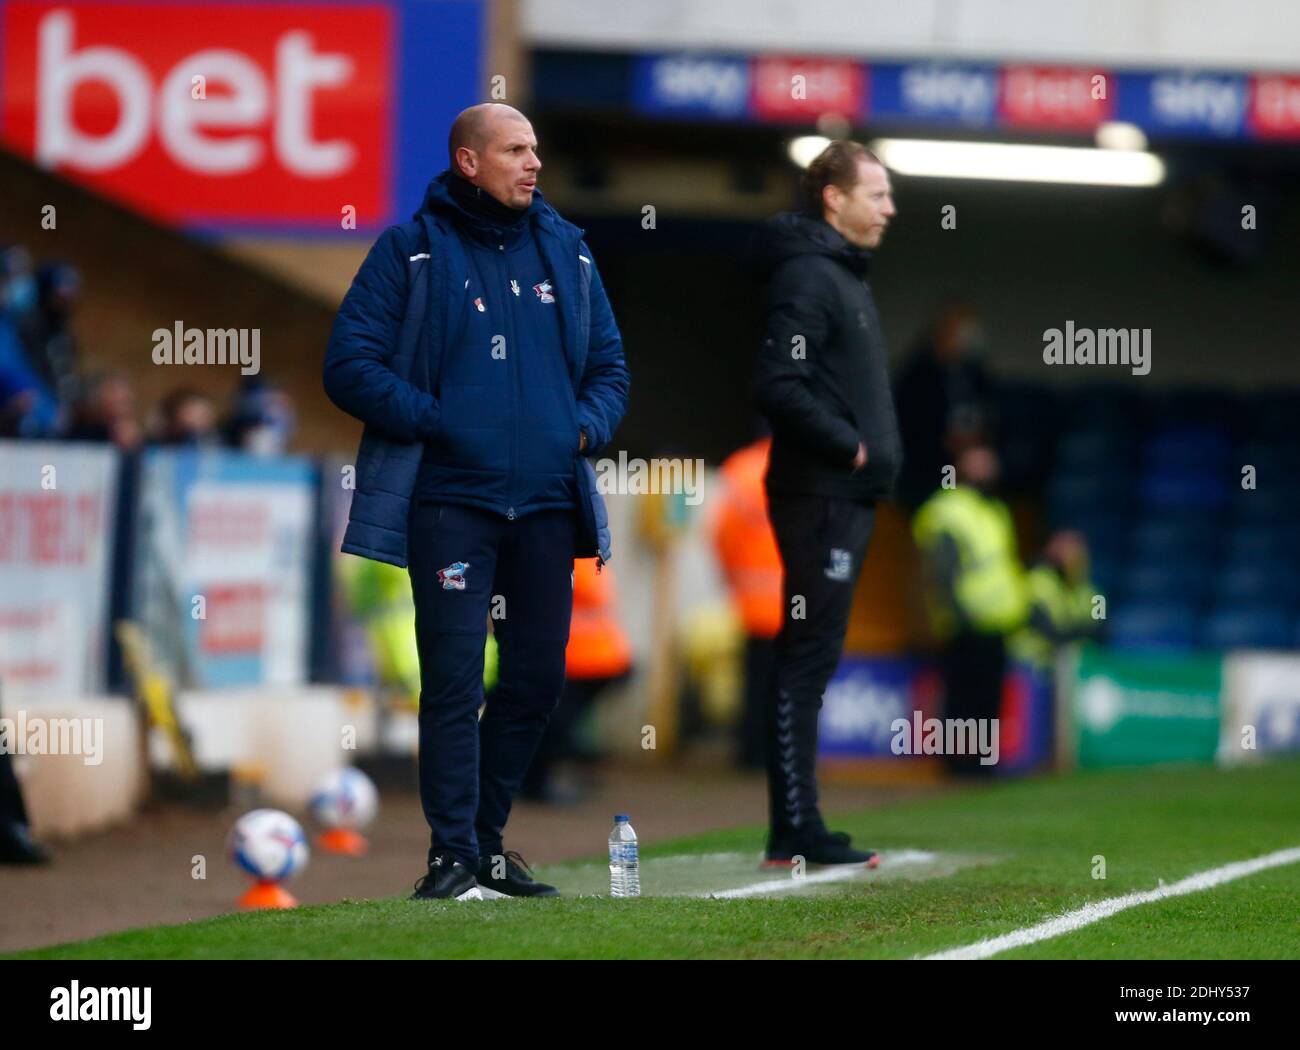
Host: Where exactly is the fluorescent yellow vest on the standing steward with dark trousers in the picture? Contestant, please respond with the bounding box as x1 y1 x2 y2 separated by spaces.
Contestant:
911 486 1028 638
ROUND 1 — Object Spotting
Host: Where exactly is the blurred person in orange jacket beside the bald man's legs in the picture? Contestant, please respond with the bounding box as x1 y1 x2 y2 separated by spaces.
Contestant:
520 557 632 802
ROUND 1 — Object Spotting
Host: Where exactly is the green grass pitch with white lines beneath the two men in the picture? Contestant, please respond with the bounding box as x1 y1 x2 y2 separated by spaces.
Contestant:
17 760 1300 959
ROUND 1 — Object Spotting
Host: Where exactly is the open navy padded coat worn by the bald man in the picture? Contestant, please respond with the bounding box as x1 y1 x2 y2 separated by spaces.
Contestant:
324 173 629 568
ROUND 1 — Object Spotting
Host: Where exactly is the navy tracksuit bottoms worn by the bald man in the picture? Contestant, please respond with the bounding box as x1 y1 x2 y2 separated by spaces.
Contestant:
408 500 577 867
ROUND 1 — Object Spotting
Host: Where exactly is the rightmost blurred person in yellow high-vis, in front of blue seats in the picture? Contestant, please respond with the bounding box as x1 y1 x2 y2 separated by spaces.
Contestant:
1010 530 1100 673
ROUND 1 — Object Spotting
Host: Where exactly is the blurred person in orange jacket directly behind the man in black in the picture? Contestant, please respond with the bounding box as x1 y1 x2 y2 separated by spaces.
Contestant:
710 437 781 769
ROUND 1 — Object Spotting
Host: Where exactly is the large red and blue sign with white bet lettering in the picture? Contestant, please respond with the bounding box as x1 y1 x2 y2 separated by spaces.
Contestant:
0 0 481 230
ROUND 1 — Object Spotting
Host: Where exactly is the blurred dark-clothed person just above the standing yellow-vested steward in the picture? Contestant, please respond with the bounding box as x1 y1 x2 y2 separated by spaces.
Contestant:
897 303 995 509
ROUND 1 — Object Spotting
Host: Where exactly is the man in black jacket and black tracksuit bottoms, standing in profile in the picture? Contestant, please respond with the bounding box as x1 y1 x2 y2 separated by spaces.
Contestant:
757 140 902 867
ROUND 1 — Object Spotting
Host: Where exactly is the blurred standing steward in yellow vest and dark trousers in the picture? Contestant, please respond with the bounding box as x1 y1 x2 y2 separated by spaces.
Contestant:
911 446 1030 775
